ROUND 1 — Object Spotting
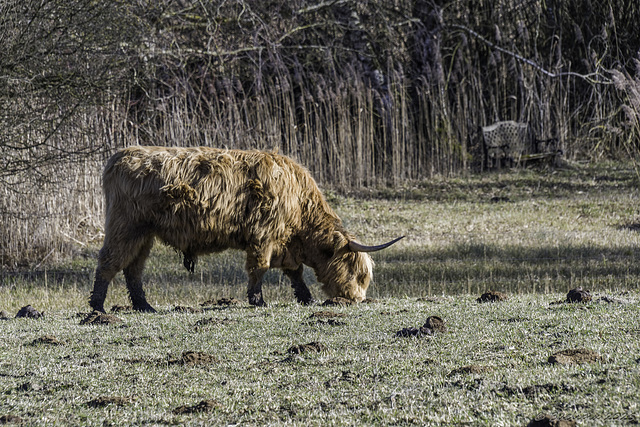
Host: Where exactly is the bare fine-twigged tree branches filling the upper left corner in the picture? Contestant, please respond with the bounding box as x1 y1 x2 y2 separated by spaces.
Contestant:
0 0 140 185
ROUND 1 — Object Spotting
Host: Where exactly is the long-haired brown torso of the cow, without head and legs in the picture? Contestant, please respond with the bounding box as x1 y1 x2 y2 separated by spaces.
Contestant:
103 147 330 254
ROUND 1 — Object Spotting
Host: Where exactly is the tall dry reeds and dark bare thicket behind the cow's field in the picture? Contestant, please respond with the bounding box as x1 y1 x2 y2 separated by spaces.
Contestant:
0 0 640 266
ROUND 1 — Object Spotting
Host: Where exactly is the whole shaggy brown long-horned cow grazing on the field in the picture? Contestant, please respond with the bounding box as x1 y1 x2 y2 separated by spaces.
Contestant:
90 147 399 311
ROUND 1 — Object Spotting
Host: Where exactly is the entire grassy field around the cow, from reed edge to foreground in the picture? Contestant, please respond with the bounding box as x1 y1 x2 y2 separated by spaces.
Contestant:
0 164 640 425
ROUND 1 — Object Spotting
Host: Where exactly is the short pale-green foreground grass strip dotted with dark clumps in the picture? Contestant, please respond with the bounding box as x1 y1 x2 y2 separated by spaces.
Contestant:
0 293 640 425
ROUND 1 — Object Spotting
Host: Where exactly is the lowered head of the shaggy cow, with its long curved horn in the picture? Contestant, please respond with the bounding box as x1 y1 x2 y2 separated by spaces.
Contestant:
319 232 404 302
